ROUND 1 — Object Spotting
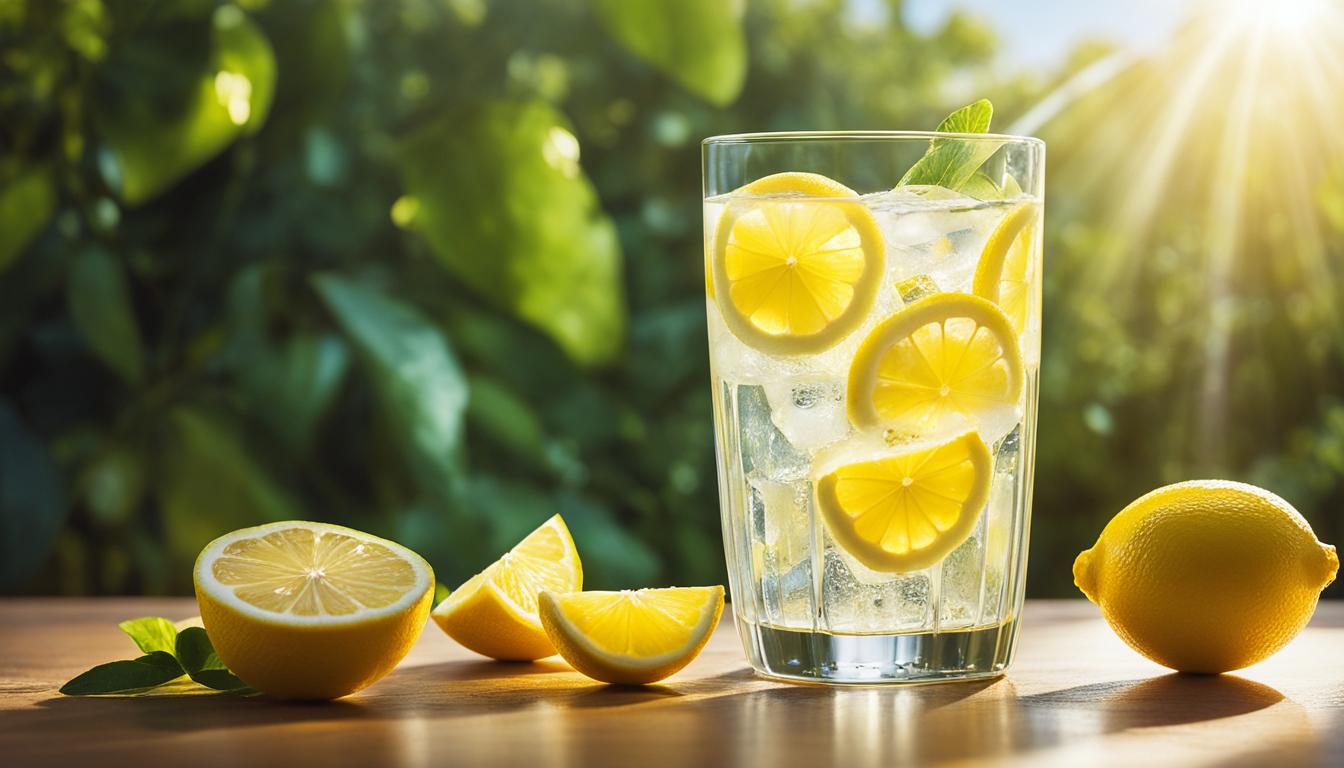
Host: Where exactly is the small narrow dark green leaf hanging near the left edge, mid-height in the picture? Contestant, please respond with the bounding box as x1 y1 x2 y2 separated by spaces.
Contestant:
66 247 145 385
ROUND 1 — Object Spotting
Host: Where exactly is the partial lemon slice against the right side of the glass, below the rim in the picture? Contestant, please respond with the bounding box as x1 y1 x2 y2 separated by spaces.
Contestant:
972 203 1040 334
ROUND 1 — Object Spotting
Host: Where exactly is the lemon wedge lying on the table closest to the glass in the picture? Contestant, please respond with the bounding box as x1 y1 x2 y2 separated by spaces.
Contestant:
540 586 723 685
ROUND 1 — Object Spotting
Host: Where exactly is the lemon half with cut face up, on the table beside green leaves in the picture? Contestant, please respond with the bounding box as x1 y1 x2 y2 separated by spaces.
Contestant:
194 522 434 699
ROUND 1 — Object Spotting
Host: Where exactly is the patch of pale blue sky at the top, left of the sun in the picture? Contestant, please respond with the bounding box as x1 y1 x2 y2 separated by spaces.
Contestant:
870 0 1198 69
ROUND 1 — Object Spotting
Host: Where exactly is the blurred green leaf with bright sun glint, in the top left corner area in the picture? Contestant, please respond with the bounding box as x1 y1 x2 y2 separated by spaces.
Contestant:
94 1 276 206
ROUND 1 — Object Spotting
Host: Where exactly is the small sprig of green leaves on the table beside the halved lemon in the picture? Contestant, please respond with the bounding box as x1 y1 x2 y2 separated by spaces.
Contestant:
60 616 253 695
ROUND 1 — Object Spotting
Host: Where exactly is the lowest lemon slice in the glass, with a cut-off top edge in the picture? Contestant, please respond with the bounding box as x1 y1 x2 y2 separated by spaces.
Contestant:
817 432 993 572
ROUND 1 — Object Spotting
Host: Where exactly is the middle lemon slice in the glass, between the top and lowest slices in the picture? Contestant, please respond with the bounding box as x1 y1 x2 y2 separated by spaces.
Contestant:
845 293 1023 436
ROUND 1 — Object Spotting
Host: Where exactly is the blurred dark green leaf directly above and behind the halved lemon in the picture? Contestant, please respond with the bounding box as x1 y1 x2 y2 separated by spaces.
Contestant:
160 406 304 566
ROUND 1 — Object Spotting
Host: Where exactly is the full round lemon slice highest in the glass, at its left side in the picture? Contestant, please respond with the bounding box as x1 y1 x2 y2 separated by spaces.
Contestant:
706 172 886 355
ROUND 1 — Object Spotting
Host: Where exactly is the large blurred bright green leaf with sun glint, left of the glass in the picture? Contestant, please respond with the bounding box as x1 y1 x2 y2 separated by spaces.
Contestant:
401 101 625 364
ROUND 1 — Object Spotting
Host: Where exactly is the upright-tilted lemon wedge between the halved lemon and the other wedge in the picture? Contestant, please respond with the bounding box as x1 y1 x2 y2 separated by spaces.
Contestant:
433 515 583 662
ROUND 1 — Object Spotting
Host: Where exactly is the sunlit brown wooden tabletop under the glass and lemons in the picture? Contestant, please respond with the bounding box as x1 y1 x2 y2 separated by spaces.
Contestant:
0 599 1344 768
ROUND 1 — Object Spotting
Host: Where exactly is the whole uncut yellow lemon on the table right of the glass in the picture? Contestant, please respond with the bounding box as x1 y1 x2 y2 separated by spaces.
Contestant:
1074 480 1339 673
